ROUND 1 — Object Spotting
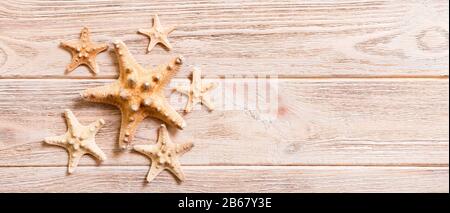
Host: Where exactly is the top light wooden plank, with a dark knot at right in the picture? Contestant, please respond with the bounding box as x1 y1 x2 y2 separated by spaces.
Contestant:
0 0 449 78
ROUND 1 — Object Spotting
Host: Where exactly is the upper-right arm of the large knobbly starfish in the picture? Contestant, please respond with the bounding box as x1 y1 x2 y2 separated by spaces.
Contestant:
155 56 184 90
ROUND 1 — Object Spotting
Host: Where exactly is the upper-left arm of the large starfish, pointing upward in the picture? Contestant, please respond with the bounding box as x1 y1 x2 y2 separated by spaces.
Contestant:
114 40 143 79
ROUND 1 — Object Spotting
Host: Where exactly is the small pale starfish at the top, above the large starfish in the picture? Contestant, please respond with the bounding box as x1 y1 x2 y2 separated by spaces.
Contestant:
138 15 175 53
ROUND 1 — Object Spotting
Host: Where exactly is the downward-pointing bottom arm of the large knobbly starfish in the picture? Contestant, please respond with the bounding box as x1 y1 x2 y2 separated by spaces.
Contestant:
119 109 145 149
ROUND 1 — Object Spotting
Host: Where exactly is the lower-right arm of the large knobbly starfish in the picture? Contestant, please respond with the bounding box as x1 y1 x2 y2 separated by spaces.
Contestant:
153 100 186 129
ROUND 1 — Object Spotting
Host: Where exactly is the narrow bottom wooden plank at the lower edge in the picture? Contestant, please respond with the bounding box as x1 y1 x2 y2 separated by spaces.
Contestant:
0 166 449 193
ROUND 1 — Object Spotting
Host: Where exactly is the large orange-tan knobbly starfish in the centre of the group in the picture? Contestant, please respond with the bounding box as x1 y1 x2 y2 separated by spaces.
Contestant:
81 40 186 149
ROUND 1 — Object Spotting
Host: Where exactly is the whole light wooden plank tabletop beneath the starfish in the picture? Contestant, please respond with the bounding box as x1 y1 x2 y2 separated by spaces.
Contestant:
0 0 449 192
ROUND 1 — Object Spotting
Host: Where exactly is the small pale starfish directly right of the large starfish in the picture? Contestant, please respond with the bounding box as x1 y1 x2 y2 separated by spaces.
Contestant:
174 67 217 112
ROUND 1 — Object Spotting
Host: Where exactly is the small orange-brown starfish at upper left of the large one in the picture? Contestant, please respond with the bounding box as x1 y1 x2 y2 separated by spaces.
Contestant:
61 27 108 74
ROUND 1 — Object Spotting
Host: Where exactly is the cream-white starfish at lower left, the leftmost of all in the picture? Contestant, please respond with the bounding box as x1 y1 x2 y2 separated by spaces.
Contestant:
44 109 106 174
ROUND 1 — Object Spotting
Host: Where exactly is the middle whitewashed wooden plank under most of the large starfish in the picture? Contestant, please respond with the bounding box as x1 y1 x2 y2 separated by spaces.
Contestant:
0 79 449 166
